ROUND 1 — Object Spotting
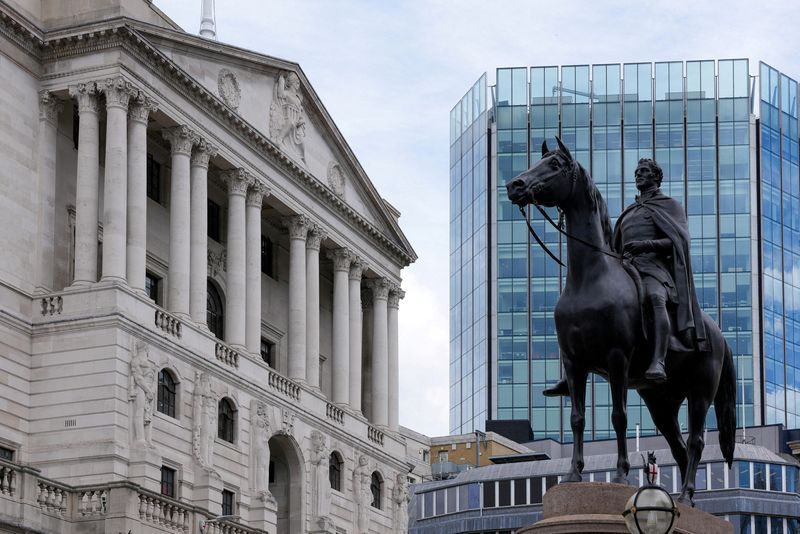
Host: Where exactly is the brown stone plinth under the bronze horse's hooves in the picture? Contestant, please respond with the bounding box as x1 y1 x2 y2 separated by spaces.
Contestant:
517 482 733 534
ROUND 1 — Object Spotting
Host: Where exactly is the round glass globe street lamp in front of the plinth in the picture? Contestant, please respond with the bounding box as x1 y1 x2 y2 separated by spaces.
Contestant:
622 452 680 534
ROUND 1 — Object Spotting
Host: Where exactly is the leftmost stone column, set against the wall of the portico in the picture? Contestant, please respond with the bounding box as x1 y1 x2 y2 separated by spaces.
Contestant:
35 91 62 293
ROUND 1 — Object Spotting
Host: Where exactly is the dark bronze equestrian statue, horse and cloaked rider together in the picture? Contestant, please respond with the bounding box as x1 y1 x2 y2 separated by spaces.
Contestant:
506 138 736 502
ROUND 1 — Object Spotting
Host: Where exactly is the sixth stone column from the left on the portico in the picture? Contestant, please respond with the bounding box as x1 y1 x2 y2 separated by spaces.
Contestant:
189 139 217 327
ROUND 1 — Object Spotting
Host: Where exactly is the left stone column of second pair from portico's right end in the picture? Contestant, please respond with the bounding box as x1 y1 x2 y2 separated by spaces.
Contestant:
331 248 352 404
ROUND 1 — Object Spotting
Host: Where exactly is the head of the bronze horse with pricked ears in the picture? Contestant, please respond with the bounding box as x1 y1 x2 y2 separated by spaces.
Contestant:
506 137 578 207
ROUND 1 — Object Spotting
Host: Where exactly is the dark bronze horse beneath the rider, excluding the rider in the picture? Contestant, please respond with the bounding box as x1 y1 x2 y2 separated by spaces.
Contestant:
506 138 736 506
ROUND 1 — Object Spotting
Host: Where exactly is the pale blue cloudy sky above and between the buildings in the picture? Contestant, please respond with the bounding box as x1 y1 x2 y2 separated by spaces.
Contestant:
155 0 800 436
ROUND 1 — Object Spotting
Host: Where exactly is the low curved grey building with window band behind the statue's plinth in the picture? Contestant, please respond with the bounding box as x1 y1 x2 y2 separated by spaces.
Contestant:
409 425 800 534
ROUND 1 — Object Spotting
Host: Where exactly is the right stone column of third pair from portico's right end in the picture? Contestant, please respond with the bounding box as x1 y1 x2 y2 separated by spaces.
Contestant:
306 224 327 388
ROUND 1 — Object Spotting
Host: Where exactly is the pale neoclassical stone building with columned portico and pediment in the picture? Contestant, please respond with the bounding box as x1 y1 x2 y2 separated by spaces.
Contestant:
0 0 416 534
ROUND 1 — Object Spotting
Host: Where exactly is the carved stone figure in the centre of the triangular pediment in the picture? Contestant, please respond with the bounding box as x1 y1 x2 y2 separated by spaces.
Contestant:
269 72 306 163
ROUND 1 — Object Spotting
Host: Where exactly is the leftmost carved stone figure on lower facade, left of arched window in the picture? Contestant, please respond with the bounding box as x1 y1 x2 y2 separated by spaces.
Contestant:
128 341 156 447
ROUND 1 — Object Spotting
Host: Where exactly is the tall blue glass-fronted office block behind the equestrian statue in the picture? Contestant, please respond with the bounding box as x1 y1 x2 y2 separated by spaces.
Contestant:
450 59 800 441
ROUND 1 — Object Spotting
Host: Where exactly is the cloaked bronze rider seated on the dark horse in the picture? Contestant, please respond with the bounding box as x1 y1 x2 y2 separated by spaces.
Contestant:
544 158 707 396
